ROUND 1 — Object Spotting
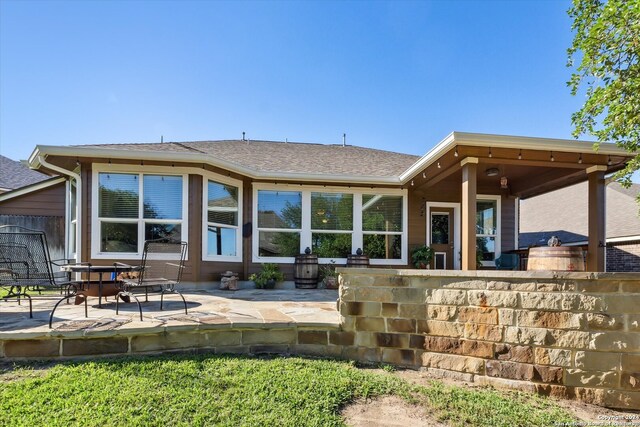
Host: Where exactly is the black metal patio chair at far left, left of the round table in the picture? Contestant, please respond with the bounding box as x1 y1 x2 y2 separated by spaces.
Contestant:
0 225 80 325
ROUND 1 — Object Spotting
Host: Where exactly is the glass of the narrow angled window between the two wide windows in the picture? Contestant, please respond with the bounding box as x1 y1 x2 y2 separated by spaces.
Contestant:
204 180 242 261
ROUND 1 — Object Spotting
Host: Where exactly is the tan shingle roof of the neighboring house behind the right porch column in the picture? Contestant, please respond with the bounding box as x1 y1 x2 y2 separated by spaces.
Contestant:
519 182 640 248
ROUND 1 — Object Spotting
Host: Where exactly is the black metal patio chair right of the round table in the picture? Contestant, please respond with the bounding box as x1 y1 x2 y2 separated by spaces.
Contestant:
116 239 187 321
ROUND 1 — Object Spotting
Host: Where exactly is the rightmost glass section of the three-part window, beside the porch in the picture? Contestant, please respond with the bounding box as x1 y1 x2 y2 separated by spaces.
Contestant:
362 194 404 259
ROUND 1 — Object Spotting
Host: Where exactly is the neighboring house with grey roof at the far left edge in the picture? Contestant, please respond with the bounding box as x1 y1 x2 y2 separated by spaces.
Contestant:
0 156 68 259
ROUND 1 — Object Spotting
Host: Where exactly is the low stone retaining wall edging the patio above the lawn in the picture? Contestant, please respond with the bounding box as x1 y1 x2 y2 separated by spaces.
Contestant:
0 325 342 360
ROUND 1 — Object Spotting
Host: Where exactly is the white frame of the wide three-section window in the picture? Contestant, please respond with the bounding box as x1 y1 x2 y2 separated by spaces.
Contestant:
252 183 408 265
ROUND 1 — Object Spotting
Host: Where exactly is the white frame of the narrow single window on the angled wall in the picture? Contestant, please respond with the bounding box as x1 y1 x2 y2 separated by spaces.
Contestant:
202 172 243 262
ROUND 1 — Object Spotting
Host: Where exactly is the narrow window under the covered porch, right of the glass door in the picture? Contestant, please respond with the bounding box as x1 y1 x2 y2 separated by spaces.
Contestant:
476 196 500 265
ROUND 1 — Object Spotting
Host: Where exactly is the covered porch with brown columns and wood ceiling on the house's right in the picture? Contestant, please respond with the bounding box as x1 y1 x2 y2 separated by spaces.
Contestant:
401 132 630 271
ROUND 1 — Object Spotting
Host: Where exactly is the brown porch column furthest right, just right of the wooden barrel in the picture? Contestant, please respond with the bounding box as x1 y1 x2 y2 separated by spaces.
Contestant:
587 165 607 271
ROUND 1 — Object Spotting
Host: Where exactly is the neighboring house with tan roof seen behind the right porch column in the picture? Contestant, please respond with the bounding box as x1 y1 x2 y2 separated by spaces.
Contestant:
519 182 640 272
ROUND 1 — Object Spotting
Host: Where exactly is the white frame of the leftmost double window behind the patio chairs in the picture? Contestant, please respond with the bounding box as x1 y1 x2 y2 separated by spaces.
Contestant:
91 163 189 260
